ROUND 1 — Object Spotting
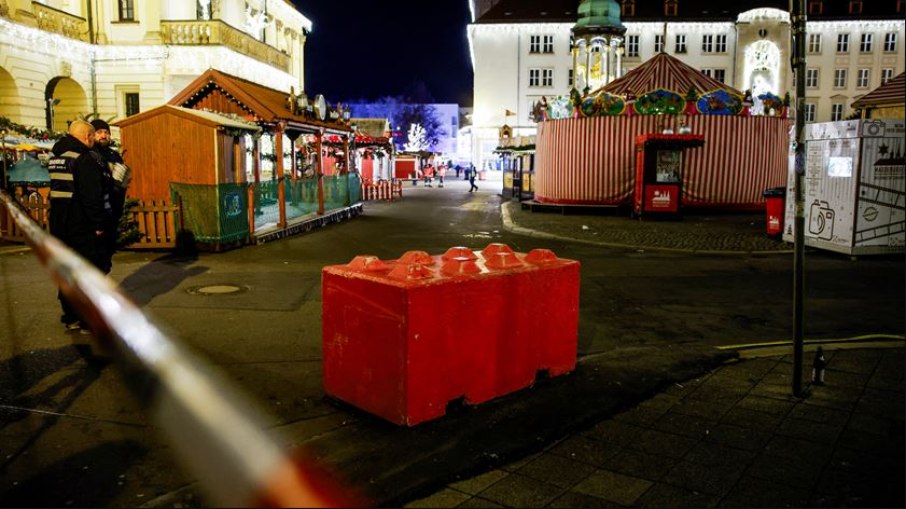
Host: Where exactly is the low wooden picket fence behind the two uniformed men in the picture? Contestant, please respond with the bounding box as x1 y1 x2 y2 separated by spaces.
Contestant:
0 194 179 249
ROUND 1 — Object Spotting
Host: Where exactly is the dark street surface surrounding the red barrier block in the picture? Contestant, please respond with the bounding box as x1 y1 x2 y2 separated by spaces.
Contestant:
0 180 906 507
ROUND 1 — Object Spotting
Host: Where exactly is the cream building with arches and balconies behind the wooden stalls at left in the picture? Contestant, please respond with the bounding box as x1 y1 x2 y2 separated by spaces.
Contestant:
0 0 312 131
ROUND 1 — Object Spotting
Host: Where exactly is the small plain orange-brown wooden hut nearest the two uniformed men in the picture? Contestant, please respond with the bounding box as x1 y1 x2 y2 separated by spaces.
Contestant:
114 105 261 246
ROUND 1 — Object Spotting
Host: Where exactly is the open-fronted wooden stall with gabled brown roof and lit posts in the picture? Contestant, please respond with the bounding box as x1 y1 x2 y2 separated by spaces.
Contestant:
162 69 362 242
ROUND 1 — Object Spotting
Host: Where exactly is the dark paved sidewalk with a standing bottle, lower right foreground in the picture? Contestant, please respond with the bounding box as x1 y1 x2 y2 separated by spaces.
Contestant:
405 347 904 508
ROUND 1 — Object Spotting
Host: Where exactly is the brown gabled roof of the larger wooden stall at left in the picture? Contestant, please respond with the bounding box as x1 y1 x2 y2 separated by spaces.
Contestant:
168 69 351 132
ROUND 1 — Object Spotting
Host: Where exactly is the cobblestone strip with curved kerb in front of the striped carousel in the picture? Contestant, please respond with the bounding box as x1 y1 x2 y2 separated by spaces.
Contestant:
501 201 792 253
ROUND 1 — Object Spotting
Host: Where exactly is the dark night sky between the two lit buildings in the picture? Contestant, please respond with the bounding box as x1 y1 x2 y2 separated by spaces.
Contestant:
292 0 472 106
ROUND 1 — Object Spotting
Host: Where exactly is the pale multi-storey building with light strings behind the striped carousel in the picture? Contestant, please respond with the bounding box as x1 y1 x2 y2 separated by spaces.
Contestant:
468 0 906 171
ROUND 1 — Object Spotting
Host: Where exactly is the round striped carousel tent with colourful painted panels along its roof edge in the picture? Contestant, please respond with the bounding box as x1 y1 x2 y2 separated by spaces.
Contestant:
534 53 790 210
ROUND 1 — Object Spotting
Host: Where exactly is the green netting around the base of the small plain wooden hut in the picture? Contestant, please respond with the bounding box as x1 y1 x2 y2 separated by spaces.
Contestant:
170 182 249 244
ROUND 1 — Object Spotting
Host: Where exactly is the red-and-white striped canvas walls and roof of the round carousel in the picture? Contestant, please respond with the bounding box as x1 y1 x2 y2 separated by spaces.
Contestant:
535 54 790 210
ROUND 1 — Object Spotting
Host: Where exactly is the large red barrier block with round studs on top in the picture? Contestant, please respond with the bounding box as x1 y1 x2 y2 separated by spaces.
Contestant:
322 244 579 426
